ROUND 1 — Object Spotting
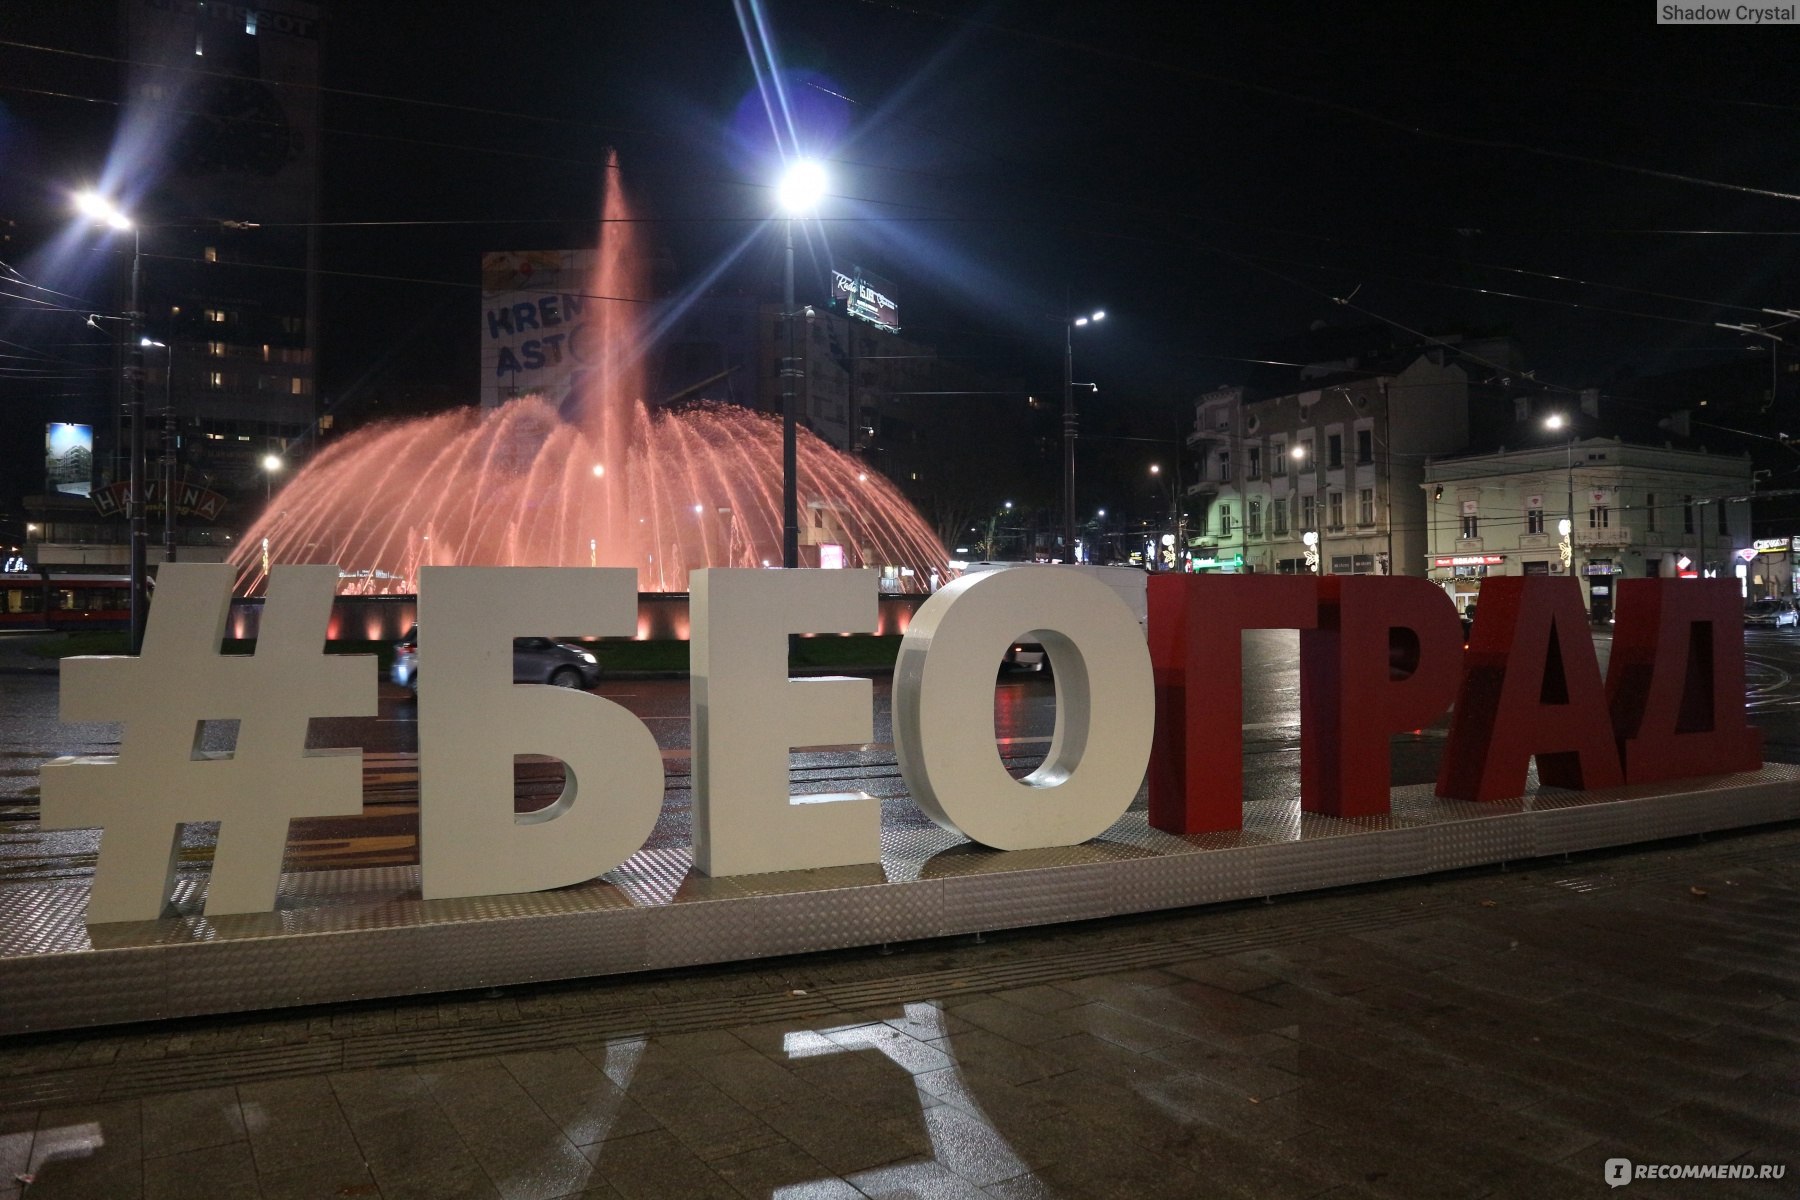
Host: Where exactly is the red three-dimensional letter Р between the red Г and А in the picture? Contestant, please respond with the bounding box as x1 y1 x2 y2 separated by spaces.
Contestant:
1300 576 1461 817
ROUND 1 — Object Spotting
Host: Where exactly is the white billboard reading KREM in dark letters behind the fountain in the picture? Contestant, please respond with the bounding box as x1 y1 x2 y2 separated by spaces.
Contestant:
481 250 598 408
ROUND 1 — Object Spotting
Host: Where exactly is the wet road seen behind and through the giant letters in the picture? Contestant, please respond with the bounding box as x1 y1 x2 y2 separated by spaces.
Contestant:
0 630 1800 885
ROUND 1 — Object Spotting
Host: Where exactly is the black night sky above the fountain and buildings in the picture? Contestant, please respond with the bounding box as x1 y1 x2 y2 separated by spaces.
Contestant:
0 0 1800 518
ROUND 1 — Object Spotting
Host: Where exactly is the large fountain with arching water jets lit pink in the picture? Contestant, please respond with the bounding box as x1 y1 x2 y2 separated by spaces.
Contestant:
232 171 950 594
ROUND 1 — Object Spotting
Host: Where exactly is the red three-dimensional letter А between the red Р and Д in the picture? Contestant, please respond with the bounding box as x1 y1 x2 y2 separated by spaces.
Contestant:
1438 576 1624 801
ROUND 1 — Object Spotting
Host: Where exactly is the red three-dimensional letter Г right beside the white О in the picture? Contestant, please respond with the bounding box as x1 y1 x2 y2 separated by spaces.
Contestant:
1147 576 1318 833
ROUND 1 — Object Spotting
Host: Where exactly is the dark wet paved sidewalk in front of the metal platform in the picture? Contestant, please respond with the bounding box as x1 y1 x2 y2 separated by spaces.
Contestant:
0 828 1800 1200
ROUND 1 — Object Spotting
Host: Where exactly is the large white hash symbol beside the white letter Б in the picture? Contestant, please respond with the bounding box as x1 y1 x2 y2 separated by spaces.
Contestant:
41 563 376 925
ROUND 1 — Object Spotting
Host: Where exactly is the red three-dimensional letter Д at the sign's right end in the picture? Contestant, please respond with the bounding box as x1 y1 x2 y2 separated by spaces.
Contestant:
1606 579 1762 783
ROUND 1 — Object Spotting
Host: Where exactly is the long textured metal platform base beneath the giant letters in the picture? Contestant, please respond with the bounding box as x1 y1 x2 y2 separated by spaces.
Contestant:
0 765 1800 1033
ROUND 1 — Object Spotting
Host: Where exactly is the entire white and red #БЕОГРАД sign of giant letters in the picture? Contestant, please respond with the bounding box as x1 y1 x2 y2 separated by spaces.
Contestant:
41 563 1760 923
